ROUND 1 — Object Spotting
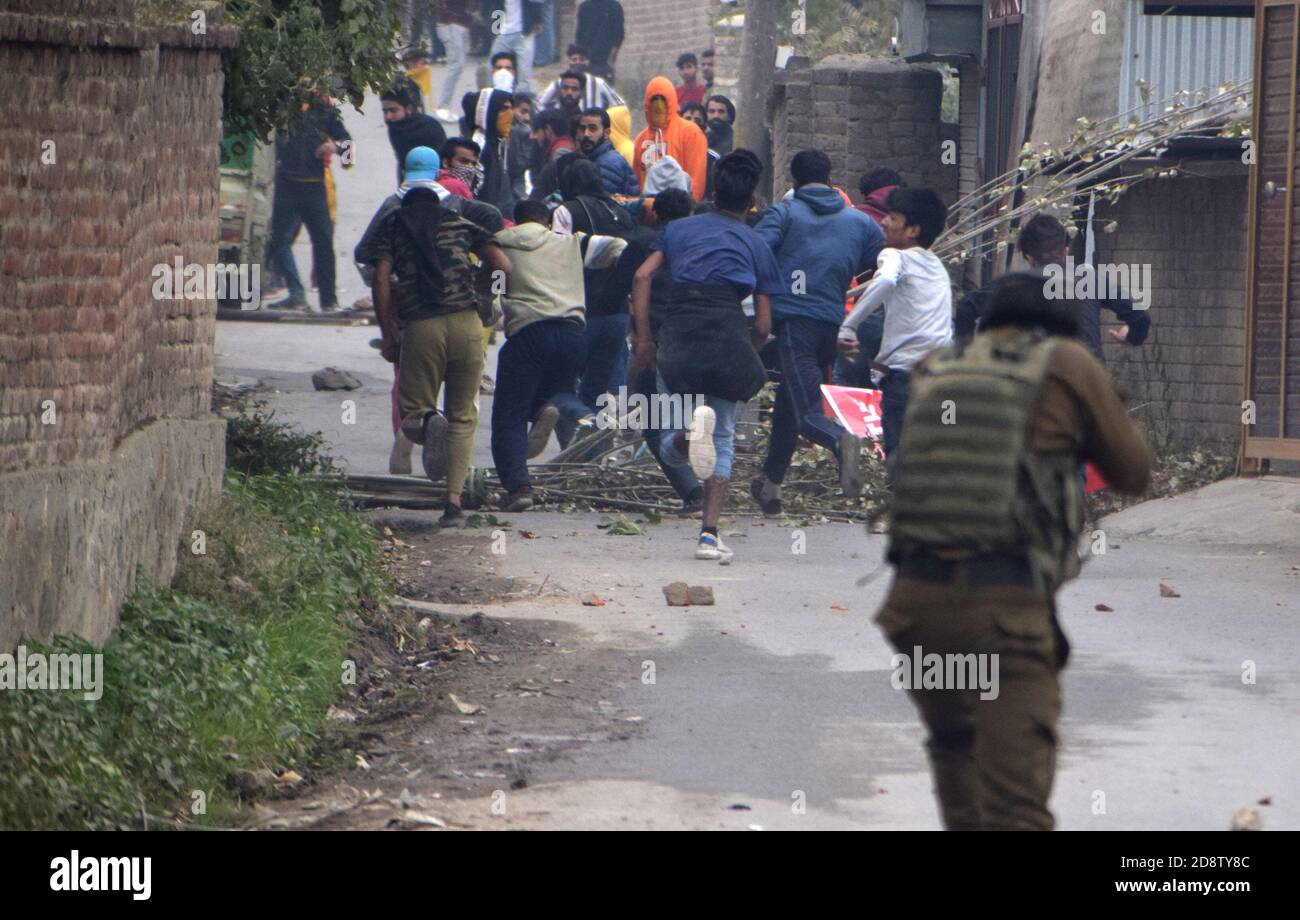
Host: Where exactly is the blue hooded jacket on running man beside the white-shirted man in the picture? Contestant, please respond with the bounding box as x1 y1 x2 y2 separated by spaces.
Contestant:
754 185 885 326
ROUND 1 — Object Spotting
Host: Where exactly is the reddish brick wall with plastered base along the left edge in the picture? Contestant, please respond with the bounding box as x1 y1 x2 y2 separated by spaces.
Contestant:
0 0 237 648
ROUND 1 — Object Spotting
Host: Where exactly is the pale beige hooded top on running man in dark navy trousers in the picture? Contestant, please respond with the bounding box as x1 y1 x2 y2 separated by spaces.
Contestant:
495 221 627 337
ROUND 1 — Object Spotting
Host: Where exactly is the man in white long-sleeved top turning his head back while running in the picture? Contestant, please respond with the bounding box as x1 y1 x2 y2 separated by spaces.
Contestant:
839 188 953 460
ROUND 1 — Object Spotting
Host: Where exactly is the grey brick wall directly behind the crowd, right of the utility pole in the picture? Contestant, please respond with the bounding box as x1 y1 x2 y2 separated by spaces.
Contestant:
771 55 959 203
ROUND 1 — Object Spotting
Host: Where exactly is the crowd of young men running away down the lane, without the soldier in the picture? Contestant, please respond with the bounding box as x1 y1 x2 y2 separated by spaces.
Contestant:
356 45 1147 545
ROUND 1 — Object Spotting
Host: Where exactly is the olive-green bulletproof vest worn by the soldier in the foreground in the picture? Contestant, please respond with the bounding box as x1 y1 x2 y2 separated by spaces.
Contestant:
889 331 1083 596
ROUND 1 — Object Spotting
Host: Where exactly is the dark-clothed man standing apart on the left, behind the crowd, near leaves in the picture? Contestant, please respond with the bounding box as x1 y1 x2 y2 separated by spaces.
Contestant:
267 94 352 311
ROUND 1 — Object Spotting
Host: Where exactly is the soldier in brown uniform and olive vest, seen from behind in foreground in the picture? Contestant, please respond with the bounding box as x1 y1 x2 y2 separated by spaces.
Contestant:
876 268 1151 830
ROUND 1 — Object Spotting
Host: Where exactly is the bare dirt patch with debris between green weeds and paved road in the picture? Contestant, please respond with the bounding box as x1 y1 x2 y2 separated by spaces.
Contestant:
239 521 640 830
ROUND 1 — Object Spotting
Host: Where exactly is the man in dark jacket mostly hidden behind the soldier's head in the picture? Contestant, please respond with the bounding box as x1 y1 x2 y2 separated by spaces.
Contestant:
956 214 1151 364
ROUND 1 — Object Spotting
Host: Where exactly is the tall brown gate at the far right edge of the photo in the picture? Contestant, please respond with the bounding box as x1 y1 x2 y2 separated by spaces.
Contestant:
1242 0 1300 460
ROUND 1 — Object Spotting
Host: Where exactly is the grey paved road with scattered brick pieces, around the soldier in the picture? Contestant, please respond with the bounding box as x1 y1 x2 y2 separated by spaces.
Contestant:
217 324 1300 829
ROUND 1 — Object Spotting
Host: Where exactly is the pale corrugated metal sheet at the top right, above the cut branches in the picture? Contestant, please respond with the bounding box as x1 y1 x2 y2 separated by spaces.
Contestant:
1118 0 1255 118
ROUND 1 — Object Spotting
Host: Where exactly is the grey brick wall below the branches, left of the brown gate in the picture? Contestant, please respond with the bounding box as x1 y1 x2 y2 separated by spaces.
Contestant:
1097 174 1247 443
